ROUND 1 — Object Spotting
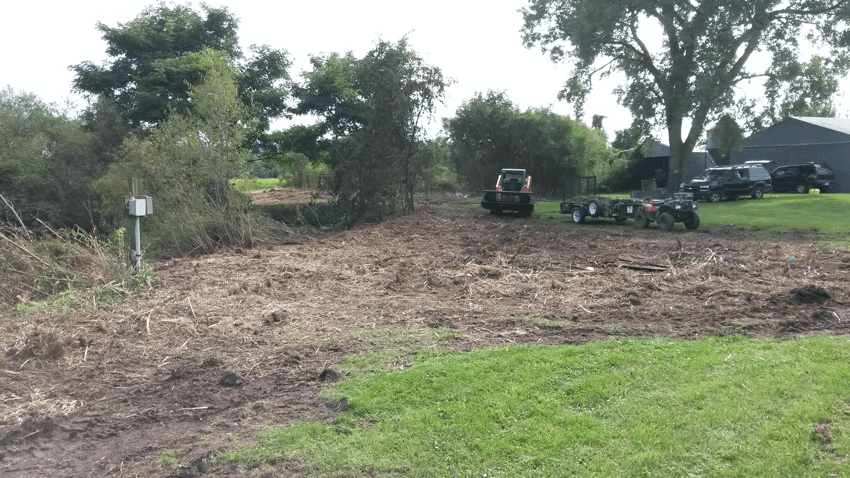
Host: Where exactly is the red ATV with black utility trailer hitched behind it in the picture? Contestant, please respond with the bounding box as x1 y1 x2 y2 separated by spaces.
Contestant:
560 178 699 231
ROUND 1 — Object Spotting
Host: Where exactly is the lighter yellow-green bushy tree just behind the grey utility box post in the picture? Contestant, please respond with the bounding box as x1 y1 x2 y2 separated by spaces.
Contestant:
94 50 255 255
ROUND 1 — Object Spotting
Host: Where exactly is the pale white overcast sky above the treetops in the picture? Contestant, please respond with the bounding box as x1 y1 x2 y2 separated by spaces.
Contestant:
0 0 848 142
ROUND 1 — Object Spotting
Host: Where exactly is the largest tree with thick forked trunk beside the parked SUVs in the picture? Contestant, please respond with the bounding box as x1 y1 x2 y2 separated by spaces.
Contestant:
522 0 850 184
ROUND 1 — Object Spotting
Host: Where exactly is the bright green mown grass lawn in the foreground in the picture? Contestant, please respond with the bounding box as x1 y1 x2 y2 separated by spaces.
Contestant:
226 336 850 477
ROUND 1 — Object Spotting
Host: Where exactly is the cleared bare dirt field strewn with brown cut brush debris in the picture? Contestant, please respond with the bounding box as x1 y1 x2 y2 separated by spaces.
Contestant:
0 191 850 477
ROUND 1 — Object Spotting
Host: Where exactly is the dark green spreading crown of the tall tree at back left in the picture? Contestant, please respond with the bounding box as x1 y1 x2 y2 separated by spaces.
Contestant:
70 2 290 131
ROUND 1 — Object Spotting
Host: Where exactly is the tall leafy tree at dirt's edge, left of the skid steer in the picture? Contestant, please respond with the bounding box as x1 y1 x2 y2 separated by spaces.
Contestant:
294 38 448 224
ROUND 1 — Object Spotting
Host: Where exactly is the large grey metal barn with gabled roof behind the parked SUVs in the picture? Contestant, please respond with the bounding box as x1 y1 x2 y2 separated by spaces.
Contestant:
731 116 850 193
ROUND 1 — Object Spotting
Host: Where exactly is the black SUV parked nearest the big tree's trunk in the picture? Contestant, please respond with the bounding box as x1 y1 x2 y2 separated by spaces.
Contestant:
680 163 771 202
